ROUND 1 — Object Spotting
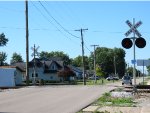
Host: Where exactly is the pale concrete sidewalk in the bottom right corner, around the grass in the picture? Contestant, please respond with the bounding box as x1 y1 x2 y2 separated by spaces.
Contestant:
82 80 150 113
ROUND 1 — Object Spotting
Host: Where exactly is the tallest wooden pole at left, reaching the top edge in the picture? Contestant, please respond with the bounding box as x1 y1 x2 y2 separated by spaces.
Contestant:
25 0 29 85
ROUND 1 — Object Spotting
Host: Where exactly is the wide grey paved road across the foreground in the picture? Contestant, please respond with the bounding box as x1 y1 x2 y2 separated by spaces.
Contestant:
0 77 145 113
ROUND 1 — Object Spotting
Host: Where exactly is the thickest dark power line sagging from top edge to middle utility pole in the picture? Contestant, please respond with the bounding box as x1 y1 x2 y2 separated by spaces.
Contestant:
39 1 79 38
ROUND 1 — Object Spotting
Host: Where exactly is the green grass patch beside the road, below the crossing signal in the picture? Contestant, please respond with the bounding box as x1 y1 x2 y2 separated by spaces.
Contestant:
94 92 135 107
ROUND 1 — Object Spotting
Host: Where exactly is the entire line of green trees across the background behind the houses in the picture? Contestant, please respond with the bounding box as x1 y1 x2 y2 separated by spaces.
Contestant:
0 33 150 77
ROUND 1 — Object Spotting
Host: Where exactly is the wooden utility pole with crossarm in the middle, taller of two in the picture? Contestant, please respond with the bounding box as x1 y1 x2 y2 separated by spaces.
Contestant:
75 28 88 85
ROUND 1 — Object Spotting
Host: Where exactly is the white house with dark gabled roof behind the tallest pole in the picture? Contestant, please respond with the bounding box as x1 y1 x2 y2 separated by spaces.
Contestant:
12 58 69 82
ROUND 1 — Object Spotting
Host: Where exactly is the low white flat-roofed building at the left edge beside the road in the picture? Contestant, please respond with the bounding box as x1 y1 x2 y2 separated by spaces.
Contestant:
0 66 22 87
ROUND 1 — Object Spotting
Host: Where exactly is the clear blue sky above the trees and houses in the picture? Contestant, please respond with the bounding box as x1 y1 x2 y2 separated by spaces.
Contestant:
0 1 150 71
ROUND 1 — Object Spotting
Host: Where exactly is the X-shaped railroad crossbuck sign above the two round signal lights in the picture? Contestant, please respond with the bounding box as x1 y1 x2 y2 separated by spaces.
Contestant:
125 20 142 37
